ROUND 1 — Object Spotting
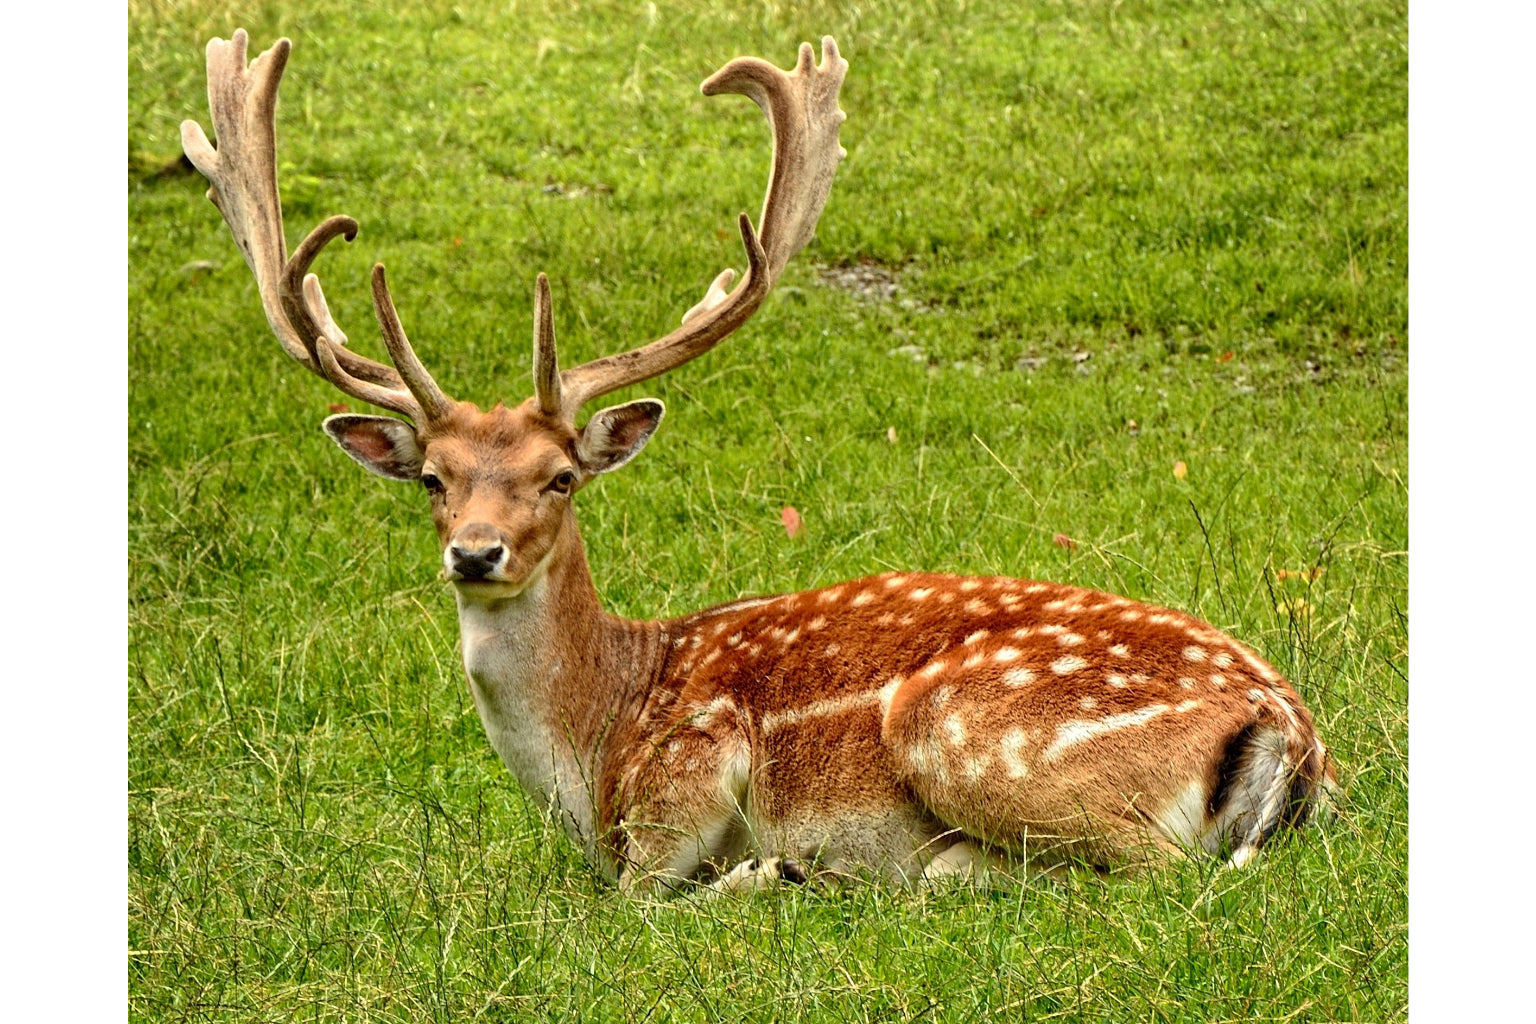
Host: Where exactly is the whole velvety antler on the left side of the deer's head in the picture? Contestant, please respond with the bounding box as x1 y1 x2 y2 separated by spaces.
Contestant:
181 29 452 424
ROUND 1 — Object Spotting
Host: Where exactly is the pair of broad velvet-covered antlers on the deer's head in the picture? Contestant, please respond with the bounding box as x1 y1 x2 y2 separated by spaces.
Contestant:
181 29 848 425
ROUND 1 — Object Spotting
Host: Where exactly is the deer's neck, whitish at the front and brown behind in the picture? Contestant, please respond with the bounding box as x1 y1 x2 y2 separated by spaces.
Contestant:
456 516 665 863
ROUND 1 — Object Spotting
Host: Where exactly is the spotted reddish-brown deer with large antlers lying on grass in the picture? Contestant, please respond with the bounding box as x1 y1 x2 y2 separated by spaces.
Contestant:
181 29 1336 895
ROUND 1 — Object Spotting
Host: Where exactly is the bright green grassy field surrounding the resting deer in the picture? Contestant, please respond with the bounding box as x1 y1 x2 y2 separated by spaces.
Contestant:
127 0 1409 1021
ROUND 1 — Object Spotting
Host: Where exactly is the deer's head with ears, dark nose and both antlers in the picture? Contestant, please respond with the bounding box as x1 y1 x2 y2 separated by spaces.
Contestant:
181 29 848 597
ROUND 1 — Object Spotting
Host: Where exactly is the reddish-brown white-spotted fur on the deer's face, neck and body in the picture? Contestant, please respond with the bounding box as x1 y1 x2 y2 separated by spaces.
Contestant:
356 401 1327 884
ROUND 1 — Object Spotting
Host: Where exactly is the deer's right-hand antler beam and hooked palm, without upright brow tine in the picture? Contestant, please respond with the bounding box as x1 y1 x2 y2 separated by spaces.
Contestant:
552 35 848 419
